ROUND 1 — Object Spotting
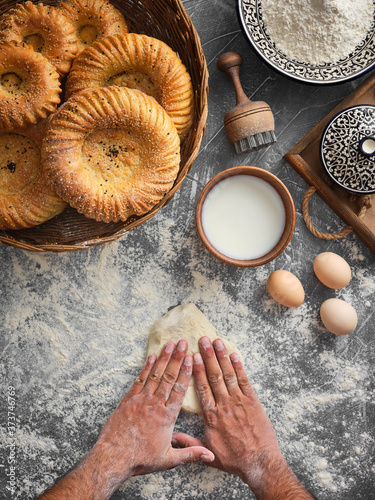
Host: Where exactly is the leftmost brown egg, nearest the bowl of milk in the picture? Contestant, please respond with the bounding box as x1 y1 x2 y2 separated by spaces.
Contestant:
267 269 305 307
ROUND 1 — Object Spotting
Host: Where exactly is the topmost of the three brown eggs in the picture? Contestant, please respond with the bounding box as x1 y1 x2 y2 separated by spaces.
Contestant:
314 252 352 289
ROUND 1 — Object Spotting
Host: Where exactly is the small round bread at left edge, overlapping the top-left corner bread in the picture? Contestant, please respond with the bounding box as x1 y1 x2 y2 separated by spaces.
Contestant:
0 42 61 131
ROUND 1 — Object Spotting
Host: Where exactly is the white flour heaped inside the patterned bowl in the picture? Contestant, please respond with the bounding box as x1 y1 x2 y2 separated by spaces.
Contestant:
261 0 374 64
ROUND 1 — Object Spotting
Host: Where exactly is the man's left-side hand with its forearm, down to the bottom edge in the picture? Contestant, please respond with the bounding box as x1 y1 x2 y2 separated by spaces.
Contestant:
41 340 215 500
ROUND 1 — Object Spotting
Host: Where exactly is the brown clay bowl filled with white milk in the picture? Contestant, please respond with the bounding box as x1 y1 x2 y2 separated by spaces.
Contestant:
195 166 295 267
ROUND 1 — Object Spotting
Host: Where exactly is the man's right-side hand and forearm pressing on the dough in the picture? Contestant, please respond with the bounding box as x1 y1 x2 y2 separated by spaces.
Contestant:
173 337 312 500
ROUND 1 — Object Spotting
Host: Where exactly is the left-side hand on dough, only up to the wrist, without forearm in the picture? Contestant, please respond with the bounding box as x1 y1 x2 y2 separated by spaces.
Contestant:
93 340 214 484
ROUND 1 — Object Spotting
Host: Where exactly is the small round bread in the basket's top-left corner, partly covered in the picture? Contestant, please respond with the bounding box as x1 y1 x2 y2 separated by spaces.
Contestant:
0 1 78 76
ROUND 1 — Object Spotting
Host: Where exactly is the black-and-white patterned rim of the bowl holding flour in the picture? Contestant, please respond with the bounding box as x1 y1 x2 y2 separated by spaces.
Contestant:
237 0 375 84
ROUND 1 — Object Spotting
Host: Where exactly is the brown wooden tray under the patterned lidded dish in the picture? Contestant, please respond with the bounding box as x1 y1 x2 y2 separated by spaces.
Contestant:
284 72 375 253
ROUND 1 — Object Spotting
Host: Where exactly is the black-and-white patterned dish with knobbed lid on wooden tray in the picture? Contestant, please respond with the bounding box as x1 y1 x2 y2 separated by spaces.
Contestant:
320 104 375 195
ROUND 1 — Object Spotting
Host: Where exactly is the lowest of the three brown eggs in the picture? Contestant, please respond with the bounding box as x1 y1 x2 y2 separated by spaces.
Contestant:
320 299 358 335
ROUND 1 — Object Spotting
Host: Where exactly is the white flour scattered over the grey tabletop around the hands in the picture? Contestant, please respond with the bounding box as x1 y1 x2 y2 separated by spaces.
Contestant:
0 212 375 500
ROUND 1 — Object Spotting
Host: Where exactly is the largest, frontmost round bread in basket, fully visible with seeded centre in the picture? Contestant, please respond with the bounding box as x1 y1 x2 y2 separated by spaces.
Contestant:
42 87 180 222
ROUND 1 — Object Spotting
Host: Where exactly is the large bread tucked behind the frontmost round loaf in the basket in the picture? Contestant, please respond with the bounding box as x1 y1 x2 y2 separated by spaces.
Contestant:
66 33 194 140
